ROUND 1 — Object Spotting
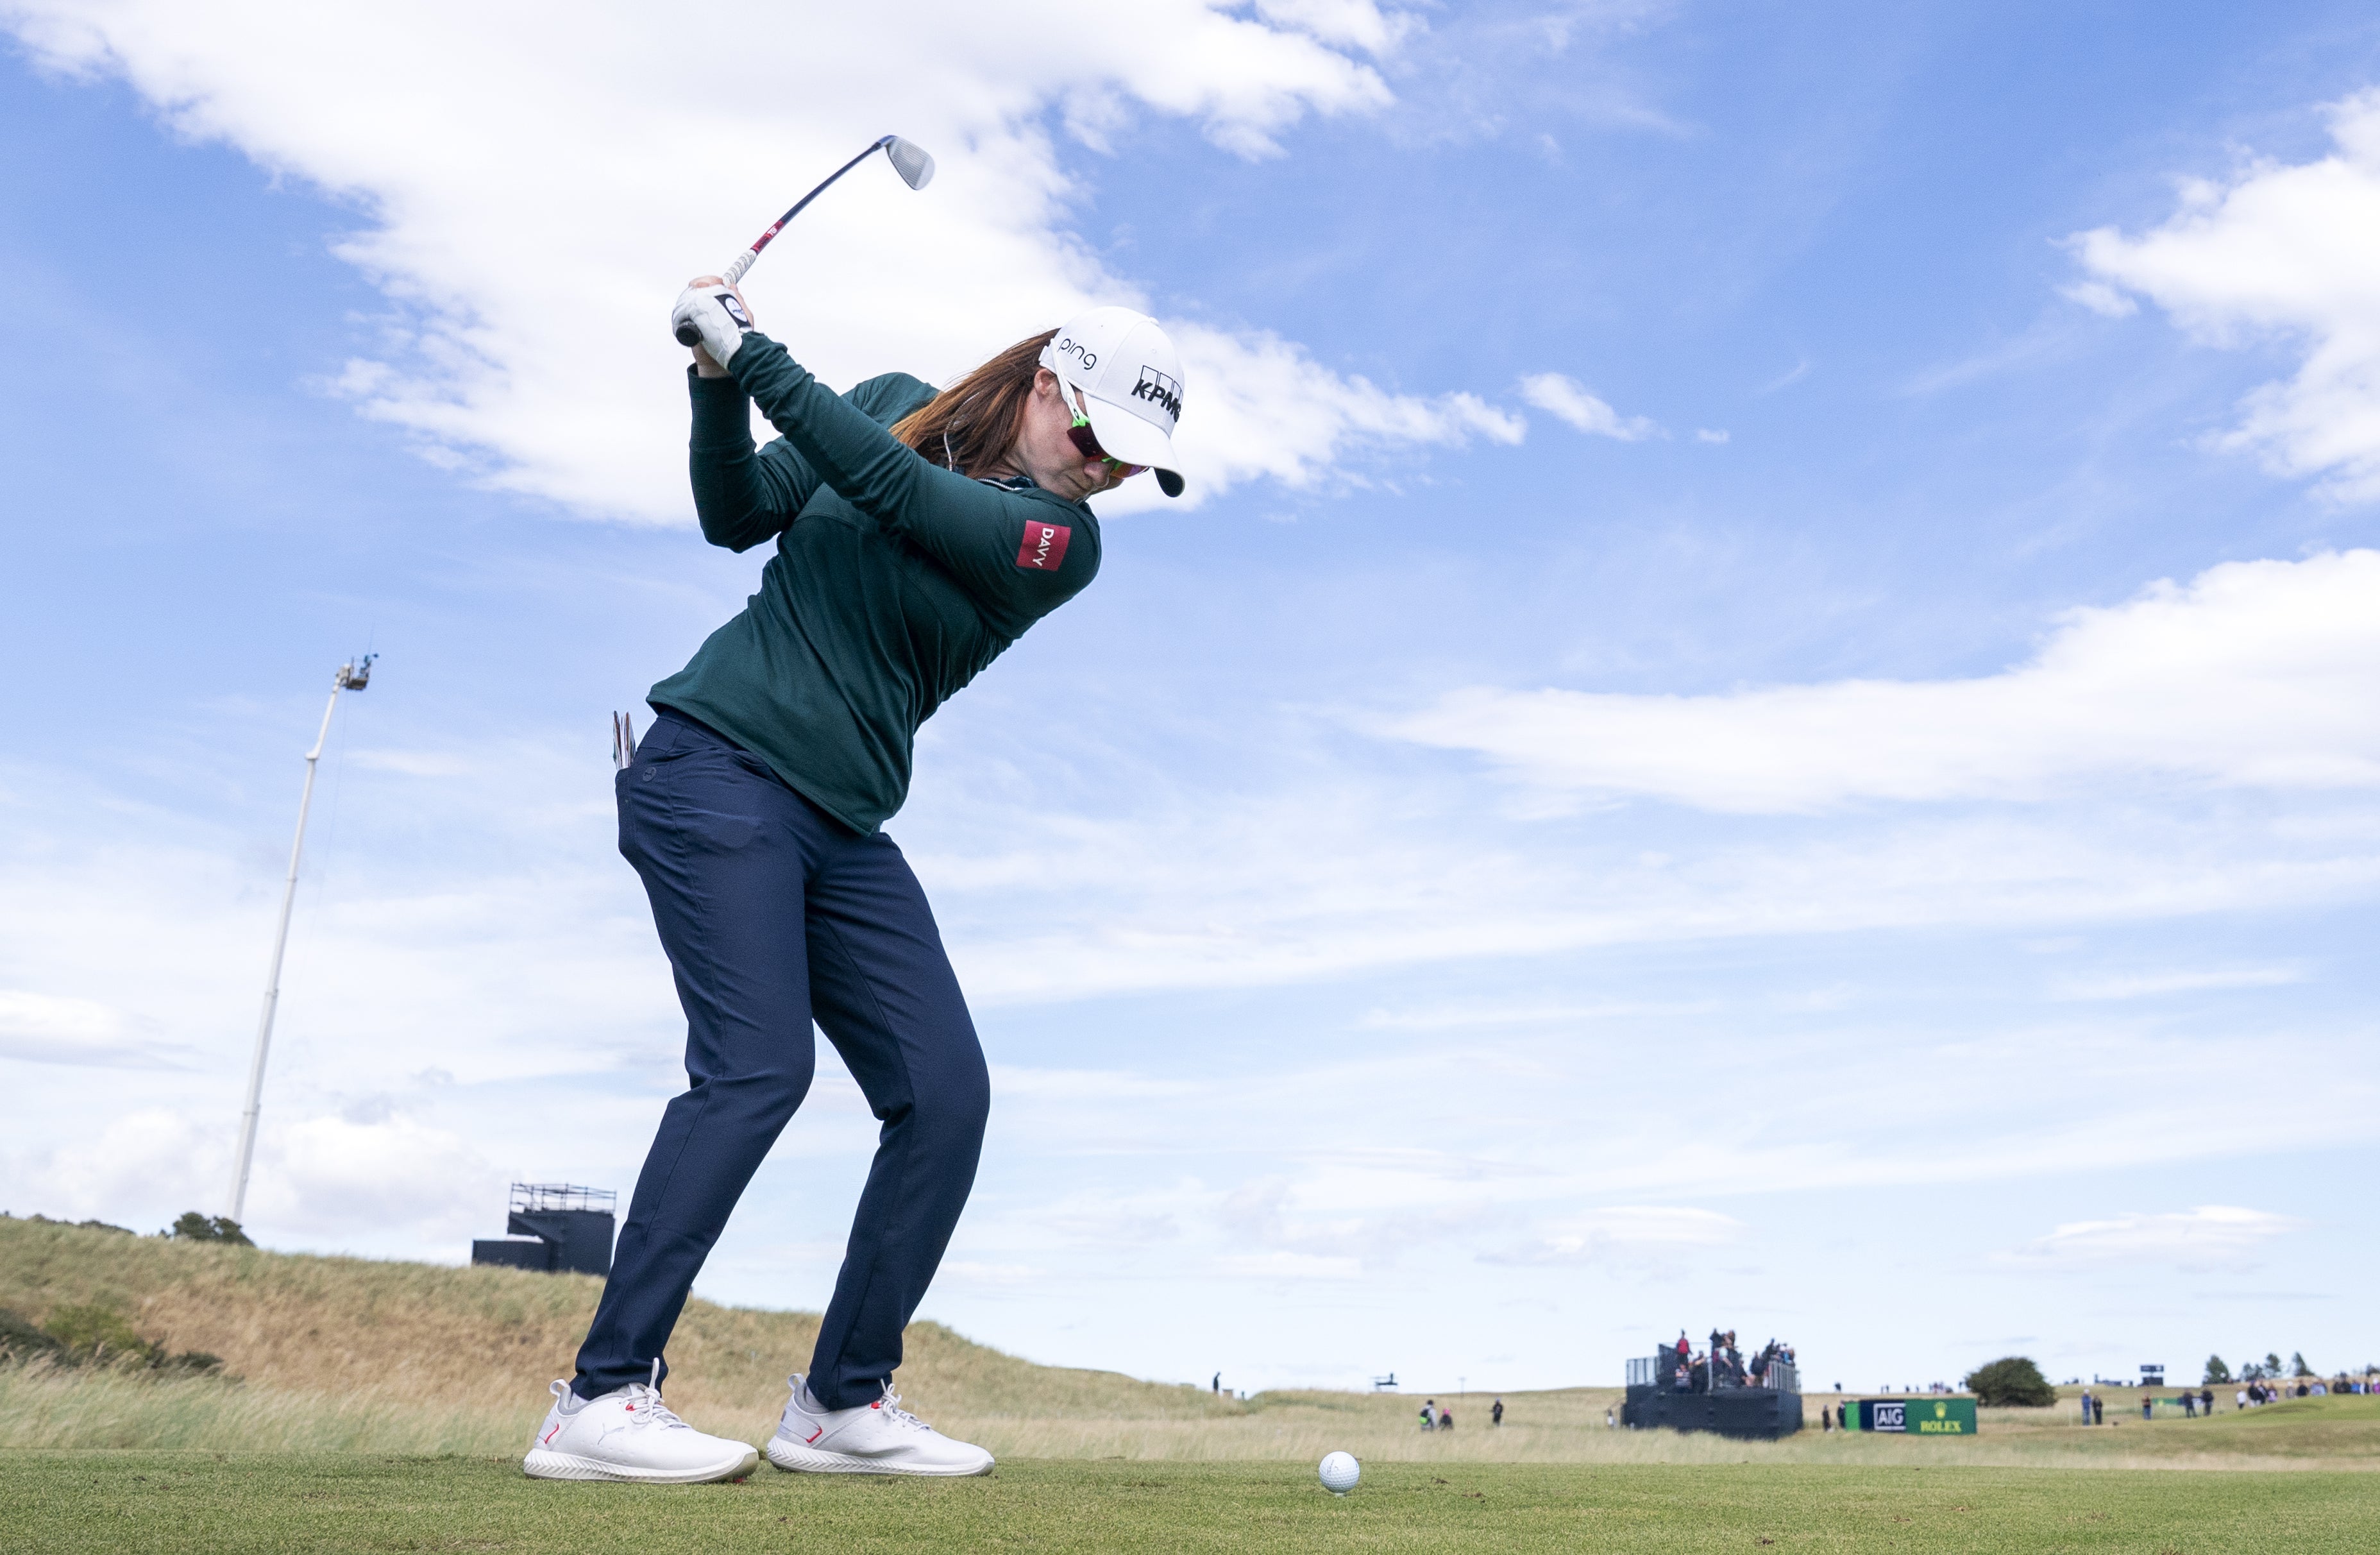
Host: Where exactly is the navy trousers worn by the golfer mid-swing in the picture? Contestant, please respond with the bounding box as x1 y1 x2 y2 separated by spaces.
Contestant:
571 710 990 1410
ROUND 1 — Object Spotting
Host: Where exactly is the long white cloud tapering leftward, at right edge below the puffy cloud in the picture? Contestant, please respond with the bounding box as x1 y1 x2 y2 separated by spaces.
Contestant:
1385 550 2380 812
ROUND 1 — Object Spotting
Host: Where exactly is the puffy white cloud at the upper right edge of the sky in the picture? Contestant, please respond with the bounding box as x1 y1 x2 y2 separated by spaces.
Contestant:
2066 90 2380 500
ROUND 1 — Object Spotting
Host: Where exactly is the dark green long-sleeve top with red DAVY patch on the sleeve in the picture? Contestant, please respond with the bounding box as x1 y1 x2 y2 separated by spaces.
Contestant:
650 334 1099 831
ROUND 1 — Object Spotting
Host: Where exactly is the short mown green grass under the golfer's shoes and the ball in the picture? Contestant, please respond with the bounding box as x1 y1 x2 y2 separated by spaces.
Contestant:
0 1452 2380 1555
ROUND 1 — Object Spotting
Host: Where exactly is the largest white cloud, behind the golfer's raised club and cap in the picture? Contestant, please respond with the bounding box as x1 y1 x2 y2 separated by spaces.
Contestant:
7 0 1521 519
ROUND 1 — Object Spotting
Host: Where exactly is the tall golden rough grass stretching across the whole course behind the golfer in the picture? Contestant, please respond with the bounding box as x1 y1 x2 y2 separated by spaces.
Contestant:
0 1217 2380 1469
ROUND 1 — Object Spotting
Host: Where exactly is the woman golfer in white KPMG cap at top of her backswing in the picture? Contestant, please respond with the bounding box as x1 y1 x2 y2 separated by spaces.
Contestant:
523 276 1183 1481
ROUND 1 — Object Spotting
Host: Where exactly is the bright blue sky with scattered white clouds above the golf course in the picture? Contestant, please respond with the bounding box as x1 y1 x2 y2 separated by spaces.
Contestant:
0 0 2380 1405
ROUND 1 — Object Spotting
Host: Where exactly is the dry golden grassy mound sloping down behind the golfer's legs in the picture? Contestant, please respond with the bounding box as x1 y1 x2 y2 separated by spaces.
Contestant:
0 1217 1242 1452
